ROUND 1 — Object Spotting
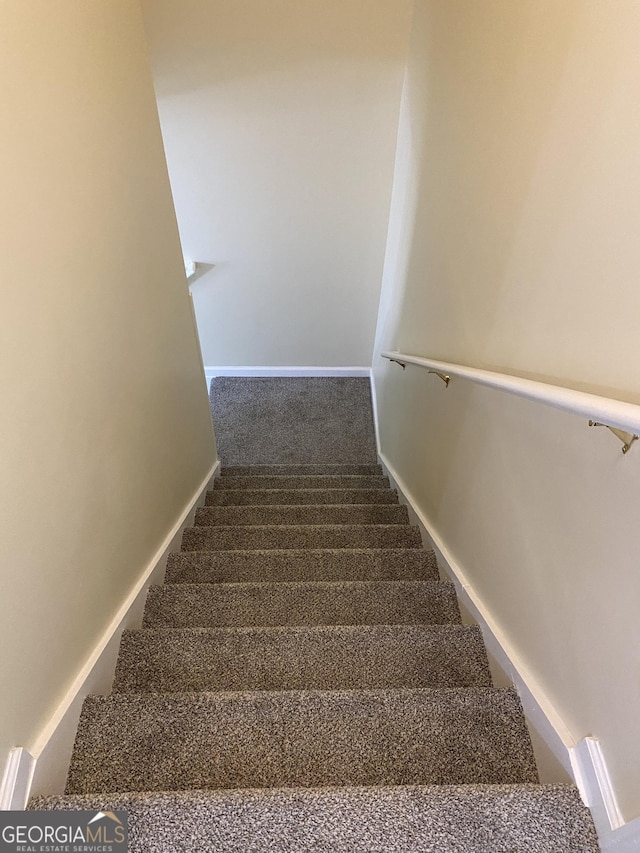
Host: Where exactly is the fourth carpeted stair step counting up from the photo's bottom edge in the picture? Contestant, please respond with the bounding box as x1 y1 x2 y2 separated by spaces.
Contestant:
143 581 460 628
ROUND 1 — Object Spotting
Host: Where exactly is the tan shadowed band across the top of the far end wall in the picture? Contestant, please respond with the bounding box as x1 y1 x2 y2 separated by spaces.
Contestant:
142 0 410 98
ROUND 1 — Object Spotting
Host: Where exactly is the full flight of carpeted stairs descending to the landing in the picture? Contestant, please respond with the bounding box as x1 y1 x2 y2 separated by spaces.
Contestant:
30 465 598 853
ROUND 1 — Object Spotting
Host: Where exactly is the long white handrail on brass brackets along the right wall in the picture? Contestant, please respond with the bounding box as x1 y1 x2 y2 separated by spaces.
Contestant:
381 351 640 433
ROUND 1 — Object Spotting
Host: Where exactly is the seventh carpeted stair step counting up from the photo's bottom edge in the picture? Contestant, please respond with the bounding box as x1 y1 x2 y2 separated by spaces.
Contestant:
195 504 409 527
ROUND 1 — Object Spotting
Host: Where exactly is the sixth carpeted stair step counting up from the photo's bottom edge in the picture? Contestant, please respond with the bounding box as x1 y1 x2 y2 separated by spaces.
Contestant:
182 524 422 551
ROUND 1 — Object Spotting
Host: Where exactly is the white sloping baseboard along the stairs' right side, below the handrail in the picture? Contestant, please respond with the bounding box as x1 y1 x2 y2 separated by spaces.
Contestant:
374 450 640 853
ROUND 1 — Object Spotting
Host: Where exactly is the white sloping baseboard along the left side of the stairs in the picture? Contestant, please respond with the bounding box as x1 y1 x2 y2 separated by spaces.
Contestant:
0 460 220 809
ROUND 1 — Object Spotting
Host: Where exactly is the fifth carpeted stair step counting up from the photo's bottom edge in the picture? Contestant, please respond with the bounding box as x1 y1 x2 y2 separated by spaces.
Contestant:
165 548 438 584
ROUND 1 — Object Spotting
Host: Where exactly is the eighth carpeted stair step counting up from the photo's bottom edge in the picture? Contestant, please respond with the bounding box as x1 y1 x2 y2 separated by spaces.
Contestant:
205 489 398 506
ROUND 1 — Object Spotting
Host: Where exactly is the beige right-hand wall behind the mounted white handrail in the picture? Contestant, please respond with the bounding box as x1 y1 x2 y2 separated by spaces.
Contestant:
374 0 640 819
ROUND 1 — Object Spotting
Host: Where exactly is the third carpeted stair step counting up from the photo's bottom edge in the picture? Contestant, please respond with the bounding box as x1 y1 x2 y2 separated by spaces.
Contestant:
113 625 491 693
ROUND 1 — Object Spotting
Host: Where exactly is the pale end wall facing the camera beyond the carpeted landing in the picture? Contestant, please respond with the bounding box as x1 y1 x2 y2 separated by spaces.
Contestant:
143 0 411 366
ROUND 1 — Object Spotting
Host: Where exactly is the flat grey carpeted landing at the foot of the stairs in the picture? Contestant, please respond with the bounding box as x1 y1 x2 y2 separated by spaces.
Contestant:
210 377 377 465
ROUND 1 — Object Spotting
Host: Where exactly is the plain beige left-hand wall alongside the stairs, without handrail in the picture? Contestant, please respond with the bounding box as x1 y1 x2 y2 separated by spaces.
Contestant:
0 0 215 764
